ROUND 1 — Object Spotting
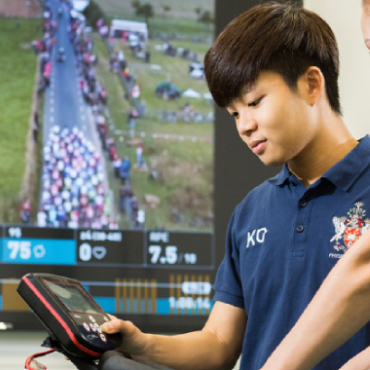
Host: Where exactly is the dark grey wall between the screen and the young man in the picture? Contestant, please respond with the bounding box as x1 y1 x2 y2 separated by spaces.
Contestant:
215 0 302 266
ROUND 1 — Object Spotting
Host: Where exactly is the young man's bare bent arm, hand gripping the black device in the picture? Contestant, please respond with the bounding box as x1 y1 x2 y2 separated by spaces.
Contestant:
102 302 247 370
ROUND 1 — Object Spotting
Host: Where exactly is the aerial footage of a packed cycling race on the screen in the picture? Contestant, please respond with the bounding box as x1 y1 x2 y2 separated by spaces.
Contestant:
0 0 214 232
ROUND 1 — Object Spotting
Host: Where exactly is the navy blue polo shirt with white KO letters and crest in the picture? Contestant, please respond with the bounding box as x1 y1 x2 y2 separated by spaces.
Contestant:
214 136 370 370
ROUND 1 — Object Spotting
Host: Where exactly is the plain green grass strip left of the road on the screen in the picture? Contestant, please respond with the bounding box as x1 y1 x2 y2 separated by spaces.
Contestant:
0 18 40 222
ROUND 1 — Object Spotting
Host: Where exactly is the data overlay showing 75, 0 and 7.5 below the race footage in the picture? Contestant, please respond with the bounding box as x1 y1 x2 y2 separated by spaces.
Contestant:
0 225 214 330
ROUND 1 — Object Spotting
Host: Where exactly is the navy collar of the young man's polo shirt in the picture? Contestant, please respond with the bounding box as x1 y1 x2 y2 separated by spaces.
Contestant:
268 135 370 191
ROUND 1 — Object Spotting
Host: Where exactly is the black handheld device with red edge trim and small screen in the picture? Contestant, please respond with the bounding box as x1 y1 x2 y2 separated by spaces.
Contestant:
17 273 121 359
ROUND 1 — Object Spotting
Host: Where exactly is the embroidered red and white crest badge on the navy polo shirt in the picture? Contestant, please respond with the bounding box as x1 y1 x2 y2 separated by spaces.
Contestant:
330 202 370 252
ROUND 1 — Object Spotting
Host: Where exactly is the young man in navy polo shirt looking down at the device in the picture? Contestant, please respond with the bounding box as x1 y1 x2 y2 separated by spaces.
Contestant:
103 3 370 370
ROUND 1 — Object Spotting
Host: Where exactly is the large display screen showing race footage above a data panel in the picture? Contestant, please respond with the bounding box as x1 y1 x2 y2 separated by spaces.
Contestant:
0 0 215 332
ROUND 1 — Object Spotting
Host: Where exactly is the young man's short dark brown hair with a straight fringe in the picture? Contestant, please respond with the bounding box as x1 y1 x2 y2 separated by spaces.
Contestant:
205 1 341 114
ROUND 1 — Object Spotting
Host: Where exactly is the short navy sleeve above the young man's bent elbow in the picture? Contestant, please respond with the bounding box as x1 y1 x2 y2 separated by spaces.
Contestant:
213 210 244 308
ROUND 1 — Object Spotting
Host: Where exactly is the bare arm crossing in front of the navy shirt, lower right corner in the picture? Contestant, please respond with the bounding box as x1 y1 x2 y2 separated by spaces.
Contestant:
261 231 370 370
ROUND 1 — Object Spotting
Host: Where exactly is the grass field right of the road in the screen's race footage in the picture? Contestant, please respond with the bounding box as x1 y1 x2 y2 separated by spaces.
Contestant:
94 37 213 230
